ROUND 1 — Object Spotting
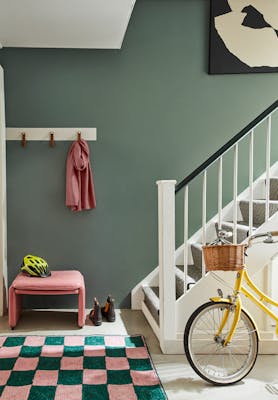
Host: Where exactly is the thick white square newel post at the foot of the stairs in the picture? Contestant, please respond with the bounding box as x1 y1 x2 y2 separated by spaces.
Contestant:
157 180 177 351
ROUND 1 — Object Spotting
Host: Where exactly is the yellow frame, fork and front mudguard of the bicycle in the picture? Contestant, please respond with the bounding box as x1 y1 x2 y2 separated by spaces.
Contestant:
211 267 278 346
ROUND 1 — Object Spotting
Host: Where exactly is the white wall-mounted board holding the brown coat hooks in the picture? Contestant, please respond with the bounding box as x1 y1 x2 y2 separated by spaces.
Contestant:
6 128 97 142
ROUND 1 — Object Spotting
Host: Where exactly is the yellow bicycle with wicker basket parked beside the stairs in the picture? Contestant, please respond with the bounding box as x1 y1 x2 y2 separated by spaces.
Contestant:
184 232 278 385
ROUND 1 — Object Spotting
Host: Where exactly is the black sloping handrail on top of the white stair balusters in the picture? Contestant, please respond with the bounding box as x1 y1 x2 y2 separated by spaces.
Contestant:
175 100 278 193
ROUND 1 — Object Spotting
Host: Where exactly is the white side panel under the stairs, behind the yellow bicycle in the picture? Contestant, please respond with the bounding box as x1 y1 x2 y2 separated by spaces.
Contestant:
172 212 278 354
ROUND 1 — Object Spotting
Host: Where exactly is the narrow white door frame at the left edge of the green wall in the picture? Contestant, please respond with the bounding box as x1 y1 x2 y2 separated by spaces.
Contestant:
0 65 7 316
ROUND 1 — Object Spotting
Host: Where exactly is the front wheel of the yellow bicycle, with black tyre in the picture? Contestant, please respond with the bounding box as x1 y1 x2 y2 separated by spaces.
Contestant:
184 302 258 385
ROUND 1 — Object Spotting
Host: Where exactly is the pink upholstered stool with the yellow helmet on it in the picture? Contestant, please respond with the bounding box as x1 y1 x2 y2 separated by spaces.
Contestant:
9 271 86 329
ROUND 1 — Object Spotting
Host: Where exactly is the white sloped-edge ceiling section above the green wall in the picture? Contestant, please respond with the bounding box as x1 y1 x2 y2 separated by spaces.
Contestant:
0 0 136 49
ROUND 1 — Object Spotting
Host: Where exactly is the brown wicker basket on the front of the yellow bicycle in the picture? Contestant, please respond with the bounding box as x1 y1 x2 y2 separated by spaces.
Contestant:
203 244 246 271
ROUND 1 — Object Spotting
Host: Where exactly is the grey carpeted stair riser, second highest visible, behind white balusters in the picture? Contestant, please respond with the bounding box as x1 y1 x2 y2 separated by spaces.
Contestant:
239 200 278 225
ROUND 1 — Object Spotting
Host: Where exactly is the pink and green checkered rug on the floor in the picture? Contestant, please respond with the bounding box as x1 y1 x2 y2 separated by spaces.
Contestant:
0 336 167 400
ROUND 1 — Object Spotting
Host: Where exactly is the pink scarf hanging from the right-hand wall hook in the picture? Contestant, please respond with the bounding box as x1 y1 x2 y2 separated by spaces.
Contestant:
66 139 96 211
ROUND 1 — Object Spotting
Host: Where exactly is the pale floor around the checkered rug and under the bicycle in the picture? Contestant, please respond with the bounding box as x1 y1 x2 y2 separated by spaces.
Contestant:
0 310 278 400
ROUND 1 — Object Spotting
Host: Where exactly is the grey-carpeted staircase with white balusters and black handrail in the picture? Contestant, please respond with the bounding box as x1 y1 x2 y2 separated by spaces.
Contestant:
132 100 278 354
